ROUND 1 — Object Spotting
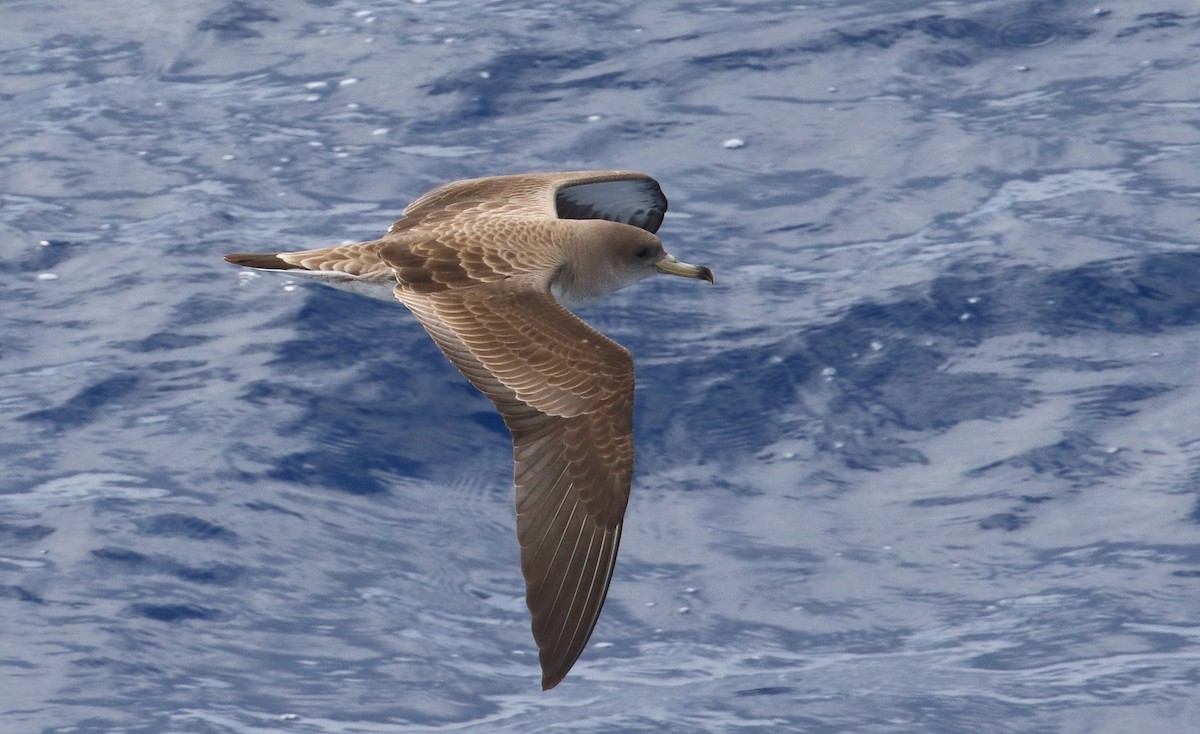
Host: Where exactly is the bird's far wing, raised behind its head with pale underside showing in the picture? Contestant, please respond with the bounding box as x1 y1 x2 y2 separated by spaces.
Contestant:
389 170 667 234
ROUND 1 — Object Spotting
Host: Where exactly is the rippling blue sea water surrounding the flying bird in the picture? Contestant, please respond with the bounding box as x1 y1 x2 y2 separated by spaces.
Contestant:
0 0 1200 734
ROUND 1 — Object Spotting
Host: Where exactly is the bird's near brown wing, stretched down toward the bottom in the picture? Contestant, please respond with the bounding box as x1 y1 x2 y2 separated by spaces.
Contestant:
396 278 634 688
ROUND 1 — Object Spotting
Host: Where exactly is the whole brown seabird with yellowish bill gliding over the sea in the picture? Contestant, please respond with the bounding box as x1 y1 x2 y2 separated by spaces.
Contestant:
226 172 713 688
